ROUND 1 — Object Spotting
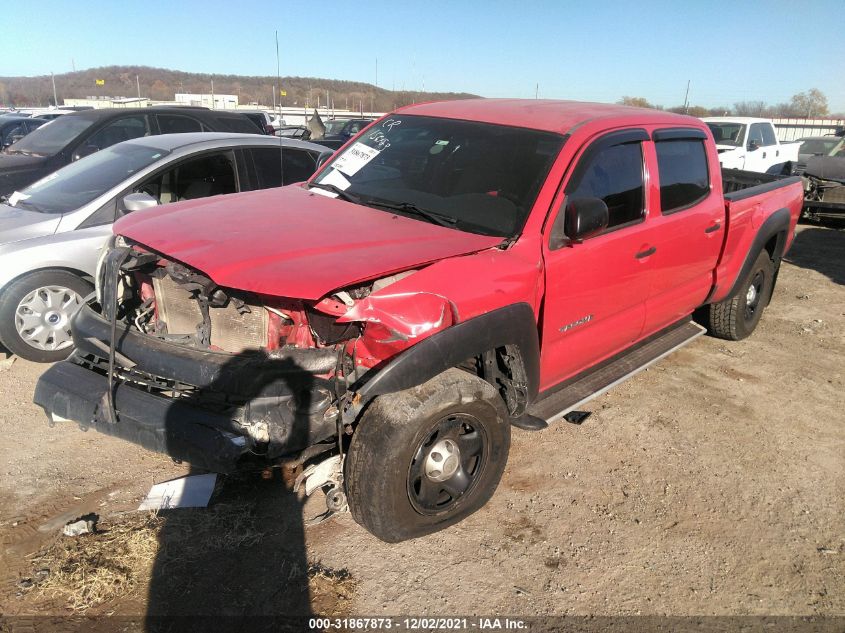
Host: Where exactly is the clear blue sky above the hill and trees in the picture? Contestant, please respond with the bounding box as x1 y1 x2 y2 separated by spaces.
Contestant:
0 0 845 112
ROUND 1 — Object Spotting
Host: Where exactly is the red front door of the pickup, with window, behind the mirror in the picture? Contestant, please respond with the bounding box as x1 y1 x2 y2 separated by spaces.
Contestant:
540 129 654 389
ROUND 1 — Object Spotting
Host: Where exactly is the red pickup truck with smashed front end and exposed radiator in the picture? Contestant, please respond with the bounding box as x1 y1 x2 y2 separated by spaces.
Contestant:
35 100 803 541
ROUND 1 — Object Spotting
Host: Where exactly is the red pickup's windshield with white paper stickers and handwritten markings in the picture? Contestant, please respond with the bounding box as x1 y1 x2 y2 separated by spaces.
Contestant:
314 115 564 237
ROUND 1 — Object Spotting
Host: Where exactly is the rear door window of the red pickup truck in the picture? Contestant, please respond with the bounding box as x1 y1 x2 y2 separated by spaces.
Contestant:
654 139 710 213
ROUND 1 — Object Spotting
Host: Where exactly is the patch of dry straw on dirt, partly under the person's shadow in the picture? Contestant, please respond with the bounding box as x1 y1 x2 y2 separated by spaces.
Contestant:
33 504 263 613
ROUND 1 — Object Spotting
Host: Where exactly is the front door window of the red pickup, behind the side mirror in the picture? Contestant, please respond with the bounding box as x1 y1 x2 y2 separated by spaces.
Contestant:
568 143 645 229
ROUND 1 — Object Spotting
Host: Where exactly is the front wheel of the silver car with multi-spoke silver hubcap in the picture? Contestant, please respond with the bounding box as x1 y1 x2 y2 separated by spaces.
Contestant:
0 270 93 363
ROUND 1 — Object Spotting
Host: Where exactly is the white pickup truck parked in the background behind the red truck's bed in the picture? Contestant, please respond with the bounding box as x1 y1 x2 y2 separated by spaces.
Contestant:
704 117 801 175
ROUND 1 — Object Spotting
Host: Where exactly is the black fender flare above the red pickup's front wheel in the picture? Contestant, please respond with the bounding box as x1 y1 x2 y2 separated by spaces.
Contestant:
352 303 540 402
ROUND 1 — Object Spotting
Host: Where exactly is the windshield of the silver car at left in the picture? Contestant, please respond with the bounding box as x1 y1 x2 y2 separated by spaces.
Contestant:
10 143 170 213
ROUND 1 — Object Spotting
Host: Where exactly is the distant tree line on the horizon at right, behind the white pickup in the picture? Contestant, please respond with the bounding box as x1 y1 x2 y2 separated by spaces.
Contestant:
617 88 845 119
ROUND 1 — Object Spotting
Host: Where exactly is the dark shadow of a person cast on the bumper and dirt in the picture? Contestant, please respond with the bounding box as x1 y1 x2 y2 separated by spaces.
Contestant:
140 351 346 633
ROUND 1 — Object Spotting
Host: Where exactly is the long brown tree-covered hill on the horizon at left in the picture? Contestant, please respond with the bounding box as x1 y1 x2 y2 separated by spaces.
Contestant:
0 66 477 112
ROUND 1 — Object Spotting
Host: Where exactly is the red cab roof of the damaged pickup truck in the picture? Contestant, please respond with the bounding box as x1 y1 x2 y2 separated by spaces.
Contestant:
397 99 702 134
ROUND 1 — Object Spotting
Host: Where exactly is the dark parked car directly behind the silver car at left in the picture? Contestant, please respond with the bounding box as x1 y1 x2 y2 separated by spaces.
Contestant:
0 108 261 196
